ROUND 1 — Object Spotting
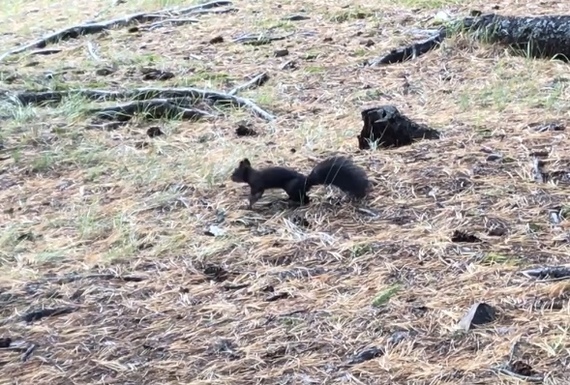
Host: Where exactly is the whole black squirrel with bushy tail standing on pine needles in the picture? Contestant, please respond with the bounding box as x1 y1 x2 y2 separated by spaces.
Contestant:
231 156 370 209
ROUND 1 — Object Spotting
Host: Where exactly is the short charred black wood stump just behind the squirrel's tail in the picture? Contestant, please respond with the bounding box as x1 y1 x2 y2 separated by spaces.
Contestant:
357 105 440 150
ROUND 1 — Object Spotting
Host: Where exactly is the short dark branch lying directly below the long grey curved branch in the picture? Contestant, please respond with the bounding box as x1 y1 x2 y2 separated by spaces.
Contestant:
89 99 216 122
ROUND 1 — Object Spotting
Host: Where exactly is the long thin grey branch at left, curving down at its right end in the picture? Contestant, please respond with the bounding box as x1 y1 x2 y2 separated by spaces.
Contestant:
0 83 275 121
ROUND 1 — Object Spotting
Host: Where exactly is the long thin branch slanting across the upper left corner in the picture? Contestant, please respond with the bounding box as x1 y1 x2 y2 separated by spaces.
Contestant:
0 1 232 62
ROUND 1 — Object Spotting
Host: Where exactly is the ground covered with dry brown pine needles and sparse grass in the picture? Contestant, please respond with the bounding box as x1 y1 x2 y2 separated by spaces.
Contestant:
0 0 570 384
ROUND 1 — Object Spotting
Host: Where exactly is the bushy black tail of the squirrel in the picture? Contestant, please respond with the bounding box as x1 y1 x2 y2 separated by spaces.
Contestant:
306 156 370 198
